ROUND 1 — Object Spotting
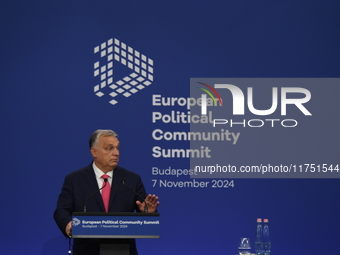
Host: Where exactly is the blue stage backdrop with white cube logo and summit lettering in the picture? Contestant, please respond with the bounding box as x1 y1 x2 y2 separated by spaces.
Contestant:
0 0 340 255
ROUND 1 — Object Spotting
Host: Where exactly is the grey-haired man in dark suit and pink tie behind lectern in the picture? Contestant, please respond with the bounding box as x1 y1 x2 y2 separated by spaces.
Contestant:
54 130 159 255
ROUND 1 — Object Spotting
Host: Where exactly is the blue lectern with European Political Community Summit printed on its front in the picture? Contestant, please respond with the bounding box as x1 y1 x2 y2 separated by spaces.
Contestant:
72 212 160 255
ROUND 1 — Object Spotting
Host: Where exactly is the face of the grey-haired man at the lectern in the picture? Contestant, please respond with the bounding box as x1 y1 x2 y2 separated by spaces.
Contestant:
91 136 120 173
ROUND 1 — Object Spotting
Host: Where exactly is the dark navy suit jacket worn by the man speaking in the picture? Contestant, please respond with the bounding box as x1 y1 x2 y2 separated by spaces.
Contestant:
54 163 146 255
